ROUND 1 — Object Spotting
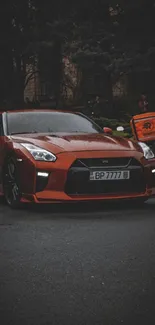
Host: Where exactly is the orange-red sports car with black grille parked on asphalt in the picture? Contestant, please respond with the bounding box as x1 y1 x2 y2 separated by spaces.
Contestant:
0 110 155 208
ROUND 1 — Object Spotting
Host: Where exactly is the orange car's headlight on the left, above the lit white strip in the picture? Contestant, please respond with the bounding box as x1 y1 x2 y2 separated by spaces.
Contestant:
21 143 57 162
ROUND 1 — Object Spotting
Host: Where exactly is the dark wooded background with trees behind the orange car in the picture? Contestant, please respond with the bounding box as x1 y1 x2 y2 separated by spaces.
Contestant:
0 0 155 118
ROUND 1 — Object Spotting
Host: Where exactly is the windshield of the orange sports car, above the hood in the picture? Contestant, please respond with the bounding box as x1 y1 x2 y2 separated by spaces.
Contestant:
7 112 103 135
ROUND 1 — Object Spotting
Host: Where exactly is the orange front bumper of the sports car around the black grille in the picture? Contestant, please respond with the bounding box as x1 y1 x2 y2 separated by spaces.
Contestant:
17 151 155 203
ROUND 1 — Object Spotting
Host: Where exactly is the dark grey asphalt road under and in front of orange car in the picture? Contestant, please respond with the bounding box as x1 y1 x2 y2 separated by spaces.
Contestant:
0 200 155 325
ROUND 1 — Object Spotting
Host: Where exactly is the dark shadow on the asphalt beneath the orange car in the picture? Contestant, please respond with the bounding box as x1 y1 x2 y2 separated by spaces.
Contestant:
0 195 155 220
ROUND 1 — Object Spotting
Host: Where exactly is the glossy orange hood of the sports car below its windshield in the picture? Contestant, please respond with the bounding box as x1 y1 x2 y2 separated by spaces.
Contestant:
12 134 136 153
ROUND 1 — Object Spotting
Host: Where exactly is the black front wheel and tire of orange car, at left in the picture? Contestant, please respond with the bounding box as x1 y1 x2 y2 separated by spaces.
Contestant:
3 156 22 209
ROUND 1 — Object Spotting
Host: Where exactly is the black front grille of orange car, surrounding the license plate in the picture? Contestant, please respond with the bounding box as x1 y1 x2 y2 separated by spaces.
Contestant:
65 157 146 195
